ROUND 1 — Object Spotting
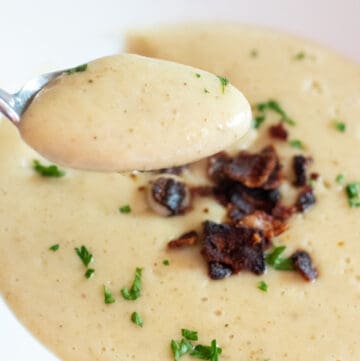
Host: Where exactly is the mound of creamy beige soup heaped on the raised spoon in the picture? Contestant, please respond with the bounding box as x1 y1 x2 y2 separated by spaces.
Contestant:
19 54 251 171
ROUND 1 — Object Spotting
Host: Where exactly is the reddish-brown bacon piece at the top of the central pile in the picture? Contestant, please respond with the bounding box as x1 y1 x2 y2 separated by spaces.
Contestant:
224 145 279 188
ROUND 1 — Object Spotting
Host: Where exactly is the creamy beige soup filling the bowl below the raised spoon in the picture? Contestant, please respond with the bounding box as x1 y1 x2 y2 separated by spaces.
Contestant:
0 25 360 361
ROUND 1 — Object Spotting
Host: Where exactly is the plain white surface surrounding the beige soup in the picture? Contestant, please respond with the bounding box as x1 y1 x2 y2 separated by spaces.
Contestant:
0 0 360 361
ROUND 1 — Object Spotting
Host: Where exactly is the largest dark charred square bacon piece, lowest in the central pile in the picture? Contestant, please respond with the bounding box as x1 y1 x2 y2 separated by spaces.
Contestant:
201 221 265 279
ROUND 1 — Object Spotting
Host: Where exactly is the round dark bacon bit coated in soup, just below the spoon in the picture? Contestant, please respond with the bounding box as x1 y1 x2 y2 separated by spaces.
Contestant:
149 176 190 216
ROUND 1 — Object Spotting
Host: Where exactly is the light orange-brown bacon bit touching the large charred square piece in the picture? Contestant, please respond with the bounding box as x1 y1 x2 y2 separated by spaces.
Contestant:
237 211 288 239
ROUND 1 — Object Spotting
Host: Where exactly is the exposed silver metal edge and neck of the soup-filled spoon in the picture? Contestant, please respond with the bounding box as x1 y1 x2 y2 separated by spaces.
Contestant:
0 69 64 125
